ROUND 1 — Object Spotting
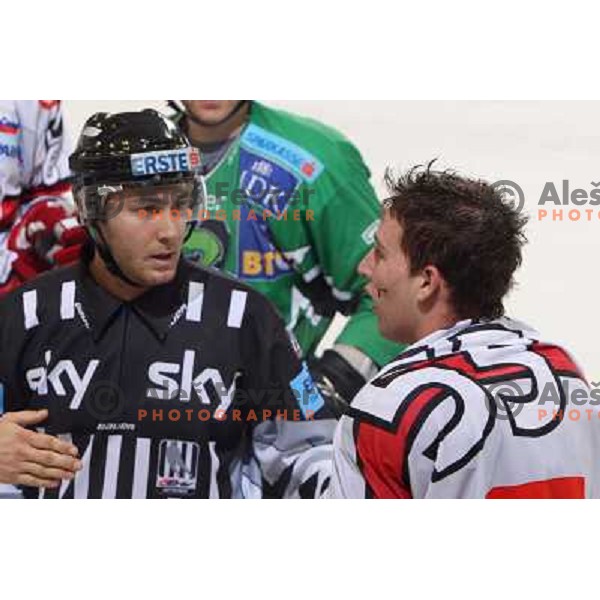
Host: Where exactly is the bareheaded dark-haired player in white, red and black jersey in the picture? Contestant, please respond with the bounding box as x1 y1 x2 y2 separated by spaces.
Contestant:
330 165 600 498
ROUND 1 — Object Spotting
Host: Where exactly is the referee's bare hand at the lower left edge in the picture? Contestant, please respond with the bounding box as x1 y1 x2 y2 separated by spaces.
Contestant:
0 409 81 488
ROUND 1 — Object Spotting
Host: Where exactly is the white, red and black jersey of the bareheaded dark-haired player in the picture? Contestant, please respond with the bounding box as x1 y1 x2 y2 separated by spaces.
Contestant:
329 318 600 498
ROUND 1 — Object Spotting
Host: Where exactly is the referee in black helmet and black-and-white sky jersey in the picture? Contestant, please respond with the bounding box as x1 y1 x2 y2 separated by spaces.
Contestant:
0 110 336 498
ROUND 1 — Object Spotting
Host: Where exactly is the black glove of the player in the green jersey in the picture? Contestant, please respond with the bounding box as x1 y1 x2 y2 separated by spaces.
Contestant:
308 350 367 419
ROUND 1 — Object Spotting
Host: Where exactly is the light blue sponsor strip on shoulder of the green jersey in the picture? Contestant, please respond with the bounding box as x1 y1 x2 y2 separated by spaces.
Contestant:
241 123 324 183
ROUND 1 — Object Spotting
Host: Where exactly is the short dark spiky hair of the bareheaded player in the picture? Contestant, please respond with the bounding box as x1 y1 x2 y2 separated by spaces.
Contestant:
384 161 527 319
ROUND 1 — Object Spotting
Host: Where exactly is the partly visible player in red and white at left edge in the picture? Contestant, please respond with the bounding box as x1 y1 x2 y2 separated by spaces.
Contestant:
0 100 85 297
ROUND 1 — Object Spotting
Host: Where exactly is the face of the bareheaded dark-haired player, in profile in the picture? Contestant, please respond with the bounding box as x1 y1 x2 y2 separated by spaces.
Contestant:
359 210 419 344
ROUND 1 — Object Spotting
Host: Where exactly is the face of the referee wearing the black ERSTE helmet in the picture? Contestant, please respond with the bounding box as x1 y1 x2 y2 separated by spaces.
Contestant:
101 185 192 287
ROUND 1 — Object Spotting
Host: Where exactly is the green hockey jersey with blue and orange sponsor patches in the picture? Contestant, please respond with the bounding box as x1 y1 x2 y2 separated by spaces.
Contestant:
180 102 401 365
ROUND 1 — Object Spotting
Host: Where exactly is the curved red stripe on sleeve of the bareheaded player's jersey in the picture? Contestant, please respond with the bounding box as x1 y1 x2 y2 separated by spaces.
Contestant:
356 386 444 499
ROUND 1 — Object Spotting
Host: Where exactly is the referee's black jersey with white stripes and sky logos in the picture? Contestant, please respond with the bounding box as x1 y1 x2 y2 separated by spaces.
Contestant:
0 260 336 498
